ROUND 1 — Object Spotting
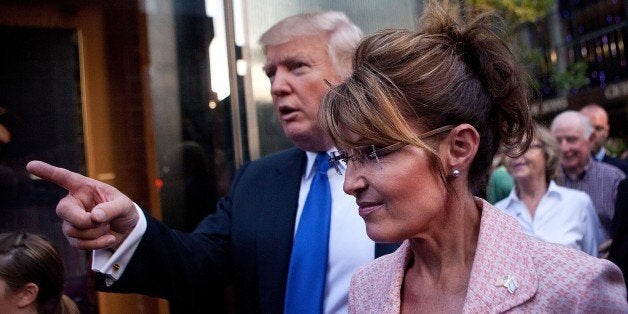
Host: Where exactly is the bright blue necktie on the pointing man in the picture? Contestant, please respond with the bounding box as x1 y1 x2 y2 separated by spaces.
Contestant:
284 152 331 314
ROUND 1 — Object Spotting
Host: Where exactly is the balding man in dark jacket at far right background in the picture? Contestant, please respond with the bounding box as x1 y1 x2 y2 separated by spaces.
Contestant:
580 103 628 174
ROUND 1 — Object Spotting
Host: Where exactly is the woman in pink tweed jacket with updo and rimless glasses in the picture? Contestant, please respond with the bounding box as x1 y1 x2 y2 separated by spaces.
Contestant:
319 2 628 313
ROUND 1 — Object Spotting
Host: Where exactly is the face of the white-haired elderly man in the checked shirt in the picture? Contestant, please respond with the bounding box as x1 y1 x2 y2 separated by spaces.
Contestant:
552 120 591 175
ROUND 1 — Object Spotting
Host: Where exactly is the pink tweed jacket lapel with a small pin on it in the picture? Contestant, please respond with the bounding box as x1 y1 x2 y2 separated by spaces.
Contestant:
464 200 539 312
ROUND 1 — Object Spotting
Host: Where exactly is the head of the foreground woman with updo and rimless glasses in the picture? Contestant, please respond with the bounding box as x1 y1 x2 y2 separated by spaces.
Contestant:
320 4 532 240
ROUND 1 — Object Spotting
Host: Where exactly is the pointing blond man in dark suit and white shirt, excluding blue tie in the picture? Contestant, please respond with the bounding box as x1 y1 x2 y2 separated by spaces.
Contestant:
27 12 395 313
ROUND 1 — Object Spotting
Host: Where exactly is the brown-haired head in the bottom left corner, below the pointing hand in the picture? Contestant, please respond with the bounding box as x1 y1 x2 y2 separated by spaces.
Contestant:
0 232 78 314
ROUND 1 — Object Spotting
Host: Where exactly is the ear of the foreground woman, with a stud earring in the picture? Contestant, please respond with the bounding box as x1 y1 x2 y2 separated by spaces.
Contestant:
443 123 480 173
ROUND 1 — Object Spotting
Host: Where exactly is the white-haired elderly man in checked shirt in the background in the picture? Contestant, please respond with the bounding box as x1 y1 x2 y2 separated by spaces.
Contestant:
550 110 626 257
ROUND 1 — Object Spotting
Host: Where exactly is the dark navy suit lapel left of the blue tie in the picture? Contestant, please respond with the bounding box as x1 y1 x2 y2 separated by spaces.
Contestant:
256 149 307 312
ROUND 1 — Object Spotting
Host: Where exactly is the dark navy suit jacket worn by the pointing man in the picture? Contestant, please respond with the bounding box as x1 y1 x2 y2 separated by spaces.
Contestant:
97 148 398 313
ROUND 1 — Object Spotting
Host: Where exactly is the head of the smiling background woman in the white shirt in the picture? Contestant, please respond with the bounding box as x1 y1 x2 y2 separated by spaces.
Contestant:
504 123 560 183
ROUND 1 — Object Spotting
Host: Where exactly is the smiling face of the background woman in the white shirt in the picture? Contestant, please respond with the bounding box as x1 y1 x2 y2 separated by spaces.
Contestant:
504 139 545 181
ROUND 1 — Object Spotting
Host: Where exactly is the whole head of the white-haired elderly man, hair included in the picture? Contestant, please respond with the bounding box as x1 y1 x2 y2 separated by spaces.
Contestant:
550 110 593 176
